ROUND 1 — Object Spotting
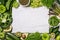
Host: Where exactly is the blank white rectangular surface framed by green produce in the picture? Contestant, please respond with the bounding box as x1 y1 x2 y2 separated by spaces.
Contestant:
12 6 49 33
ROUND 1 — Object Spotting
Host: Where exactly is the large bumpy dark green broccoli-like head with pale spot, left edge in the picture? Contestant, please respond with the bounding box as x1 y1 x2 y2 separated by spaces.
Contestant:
0 12 12 28
